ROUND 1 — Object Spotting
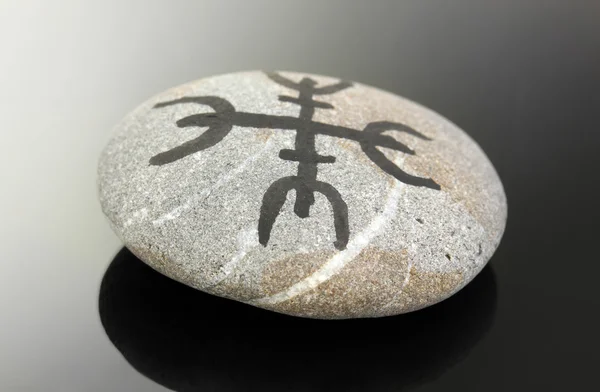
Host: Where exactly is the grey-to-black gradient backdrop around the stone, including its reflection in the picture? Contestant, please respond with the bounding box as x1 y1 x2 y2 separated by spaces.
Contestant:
0 0 600 391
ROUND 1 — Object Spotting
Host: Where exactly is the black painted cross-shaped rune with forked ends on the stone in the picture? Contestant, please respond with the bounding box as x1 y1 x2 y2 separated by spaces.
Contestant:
150 73 440 250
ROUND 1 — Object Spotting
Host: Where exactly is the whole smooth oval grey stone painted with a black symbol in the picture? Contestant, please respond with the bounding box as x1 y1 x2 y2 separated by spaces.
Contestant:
98 72 507 319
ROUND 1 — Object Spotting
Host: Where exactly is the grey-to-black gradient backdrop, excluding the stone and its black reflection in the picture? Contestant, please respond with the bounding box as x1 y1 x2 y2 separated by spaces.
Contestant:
0 0 600 391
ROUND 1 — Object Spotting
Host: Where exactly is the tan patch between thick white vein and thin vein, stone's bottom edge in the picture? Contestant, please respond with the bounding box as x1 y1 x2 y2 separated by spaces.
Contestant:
265 248 409 319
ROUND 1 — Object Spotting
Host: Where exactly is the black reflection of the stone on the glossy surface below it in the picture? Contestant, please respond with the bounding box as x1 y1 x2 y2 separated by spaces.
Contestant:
99 248 496 391
